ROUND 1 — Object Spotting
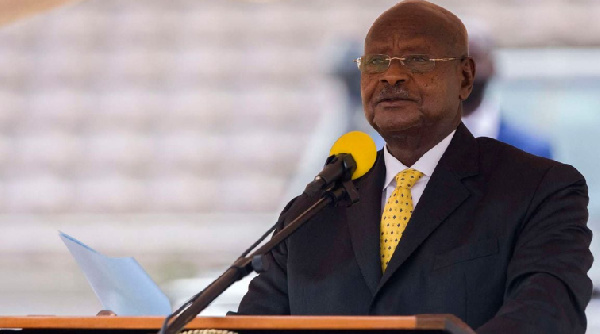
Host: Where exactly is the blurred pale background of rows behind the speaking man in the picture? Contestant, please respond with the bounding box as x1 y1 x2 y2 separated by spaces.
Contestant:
0 0 600 332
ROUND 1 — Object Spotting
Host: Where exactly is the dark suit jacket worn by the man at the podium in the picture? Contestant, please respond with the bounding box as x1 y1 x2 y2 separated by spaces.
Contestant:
239 124 592 334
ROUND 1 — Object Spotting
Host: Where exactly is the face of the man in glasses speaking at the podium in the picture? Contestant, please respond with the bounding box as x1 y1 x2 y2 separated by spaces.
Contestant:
361 24 468 141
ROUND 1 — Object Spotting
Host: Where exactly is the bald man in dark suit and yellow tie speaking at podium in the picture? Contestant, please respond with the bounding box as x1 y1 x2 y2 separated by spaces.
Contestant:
239 0 592 334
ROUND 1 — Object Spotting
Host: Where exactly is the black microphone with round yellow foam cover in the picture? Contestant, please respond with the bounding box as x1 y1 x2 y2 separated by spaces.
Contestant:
304 131 377 196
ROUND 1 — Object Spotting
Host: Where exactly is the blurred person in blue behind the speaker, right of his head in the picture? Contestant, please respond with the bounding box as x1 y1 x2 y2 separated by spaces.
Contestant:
463 21 552 159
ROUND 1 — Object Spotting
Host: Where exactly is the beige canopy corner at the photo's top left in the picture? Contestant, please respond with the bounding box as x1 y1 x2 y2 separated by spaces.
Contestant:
0 0 80 27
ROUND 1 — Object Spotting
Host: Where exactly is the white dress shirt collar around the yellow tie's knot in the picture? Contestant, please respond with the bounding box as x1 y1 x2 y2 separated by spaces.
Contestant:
381 130 456 212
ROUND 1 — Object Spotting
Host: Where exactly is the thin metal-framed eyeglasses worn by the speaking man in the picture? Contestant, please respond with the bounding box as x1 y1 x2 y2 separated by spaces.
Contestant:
354 55 465 74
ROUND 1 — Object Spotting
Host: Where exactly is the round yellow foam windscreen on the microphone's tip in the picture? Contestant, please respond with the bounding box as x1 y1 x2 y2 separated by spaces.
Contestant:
329 131 377 180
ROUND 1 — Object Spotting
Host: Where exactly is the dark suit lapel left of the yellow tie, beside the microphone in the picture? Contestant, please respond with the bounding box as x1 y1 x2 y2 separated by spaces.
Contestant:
346 151 385 295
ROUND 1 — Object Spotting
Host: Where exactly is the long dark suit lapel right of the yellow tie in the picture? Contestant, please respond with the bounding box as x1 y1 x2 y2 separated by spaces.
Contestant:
377 124 478 290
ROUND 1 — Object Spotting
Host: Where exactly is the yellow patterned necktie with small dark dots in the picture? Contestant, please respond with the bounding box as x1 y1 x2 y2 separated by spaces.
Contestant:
379 168 423 272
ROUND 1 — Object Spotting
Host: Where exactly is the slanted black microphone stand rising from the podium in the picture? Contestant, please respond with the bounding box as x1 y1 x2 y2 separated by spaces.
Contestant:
159 179 359 334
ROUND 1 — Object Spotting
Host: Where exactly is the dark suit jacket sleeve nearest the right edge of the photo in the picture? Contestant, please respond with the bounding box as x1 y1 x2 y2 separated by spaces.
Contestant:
477 165 593 334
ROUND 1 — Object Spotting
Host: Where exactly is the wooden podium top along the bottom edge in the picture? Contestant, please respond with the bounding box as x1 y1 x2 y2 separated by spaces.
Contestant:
0 315 475 334
